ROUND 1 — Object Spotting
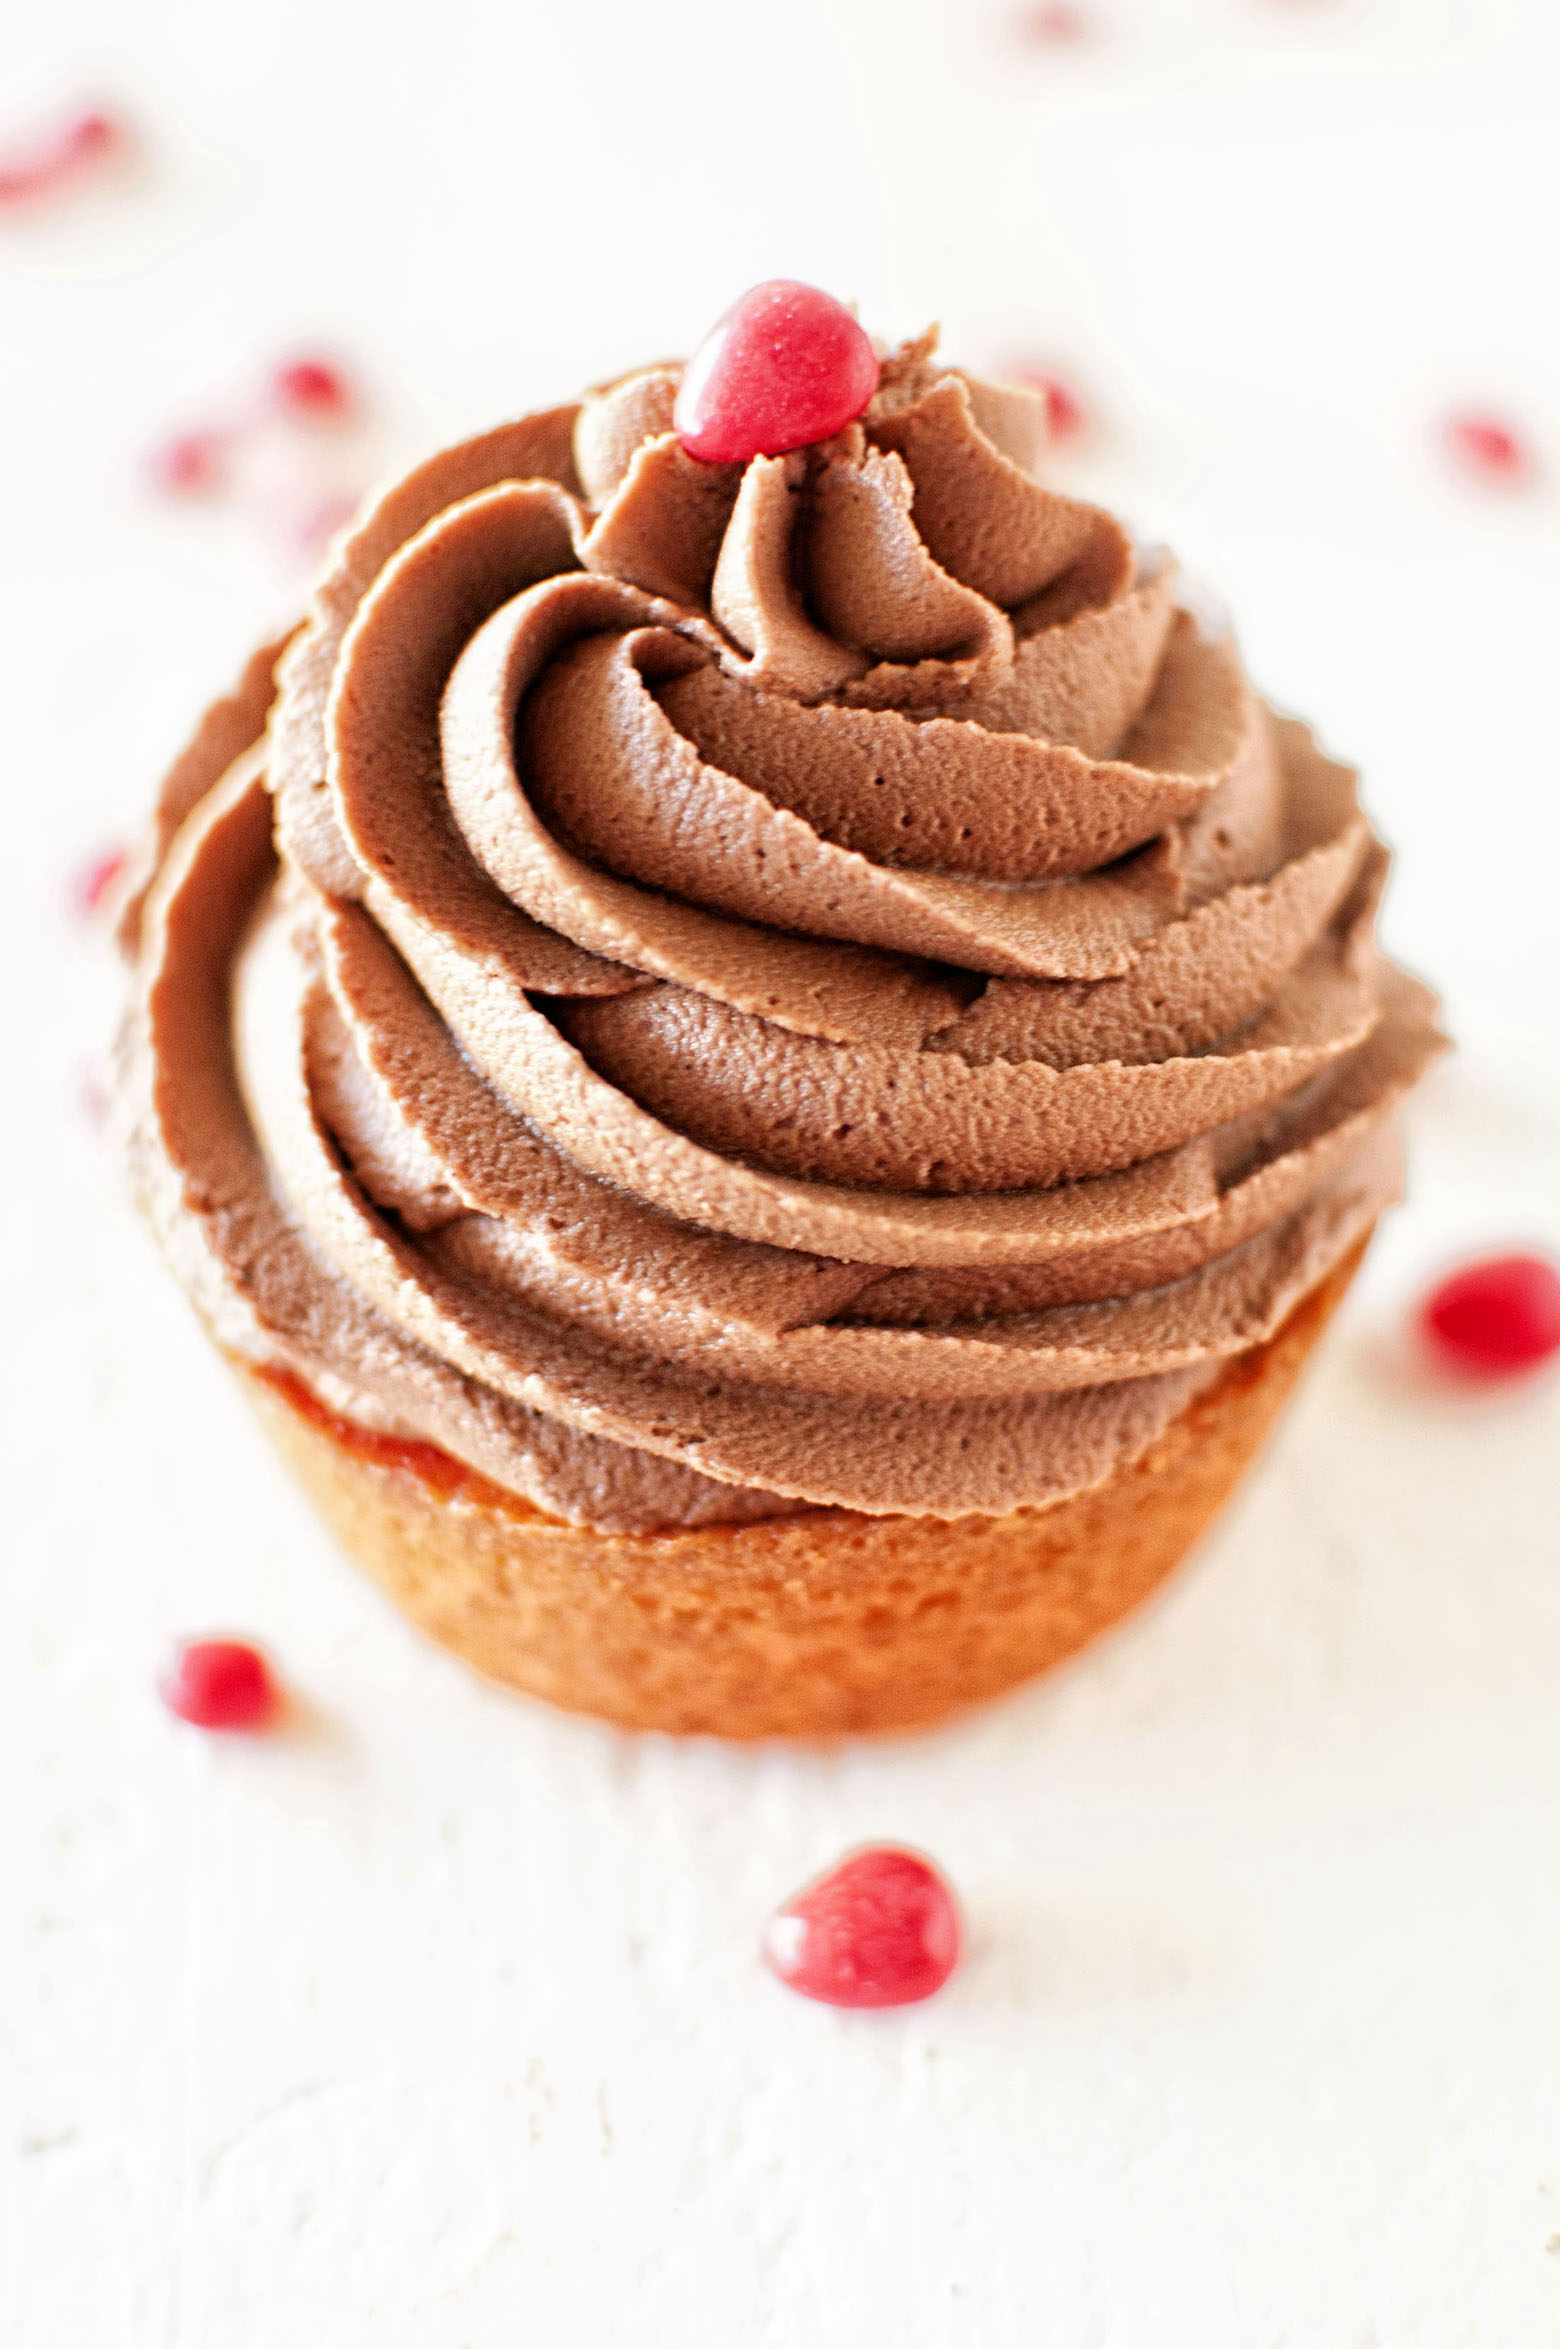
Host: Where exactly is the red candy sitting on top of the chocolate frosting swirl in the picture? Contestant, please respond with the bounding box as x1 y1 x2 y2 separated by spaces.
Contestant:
672 277 879 465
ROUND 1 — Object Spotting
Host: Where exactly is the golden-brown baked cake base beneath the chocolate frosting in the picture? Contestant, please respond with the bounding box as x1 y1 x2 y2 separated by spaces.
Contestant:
235 1243 1367 1738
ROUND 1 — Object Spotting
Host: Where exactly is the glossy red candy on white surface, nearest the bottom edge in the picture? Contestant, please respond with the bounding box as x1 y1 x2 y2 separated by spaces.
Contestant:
764 1844 959 2006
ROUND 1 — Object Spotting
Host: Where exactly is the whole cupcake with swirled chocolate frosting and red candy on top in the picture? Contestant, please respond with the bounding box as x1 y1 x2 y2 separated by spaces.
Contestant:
122 287 1440 1736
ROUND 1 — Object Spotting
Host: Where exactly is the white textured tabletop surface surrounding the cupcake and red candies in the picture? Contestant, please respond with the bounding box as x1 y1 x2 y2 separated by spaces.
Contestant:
0 0 1560 2349
